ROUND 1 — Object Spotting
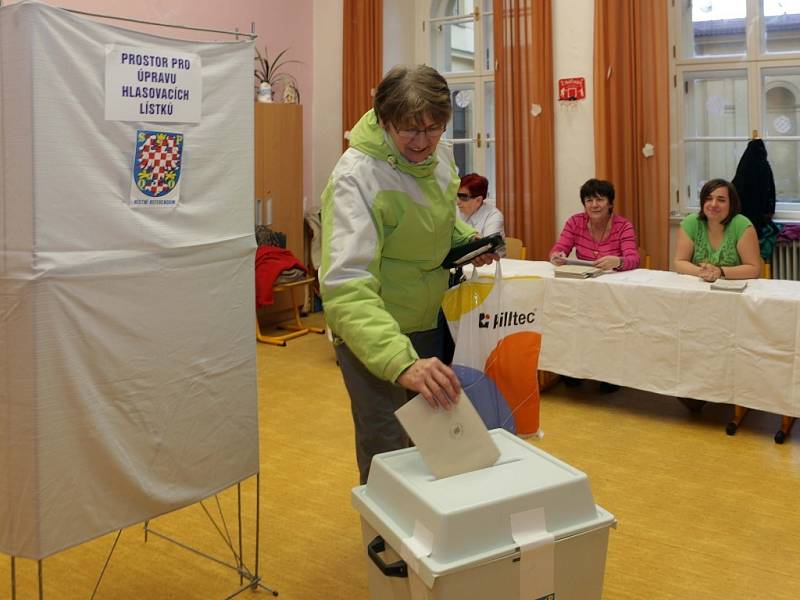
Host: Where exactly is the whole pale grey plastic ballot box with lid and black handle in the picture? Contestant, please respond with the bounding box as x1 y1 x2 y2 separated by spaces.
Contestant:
352 429 616 600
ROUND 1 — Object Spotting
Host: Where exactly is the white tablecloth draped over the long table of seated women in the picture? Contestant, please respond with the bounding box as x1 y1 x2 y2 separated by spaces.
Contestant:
480 259 800 416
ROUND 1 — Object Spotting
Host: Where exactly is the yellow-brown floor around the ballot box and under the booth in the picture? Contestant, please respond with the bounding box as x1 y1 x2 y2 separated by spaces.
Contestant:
0 312 800 600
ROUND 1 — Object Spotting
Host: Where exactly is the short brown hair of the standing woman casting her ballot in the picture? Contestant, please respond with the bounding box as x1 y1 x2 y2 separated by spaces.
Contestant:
373 65 453 128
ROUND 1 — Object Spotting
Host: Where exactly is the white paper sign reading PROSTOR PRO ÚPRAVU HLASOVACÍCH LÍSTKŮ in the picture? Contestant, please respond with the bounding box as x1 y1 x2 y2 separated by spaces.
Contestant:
105 44 203 123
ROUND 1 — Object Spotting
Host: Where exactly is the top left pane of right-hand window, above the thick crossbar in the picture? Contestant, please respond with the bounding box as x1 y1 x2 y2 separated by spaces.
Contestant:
683 0 747 57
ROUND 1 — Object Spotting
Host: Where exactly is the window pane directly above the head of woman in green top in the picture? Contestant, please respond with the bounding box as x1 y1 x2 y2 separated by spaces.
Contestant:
681 142 747 206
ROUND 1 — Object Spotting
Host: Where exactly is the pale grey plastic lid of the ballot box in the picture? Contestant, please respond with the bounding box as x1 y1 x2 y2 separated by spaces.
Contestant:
352 429 614 579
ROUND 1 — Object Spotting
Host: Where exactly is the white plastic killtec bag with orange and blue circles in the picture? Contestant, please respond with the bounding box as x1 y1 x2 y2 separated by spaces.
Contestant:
442 262 544 435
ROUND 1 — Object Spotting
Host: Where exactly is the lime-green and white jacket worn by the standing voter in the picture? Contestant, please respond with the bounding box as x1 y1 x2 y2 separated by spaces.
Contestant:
320 110 475 381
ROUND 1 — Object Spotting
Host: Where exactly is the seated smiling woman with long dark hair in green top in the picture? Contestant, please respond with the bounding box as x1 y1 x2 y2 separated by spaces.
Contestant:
675 179 762 281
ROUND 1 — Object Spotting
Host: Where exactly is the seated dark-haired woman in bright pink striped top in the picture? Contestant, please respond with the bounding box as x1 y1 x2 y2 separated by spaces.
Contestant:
550 179 639 271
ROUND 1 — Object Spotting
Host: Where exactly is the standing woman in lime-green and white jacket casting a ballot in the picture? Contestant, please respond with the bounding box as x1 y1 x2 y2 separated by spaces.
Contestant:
320 66 495 483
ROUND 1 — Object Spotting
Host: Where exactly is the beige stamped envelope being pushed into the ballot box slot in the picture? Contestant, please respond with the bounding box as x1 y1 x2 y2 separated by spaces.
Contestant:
394 390 500 479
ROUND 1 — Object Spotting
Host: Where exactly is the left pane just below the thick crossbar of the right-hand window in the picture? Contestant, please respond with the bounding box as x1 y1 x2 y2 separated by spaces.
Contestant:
685 71 749 137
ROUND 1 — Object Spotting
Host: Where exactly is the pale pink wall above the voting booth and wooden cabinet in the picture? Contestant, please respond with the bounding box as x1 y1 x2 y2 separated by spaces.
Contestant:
3 0 314 202
